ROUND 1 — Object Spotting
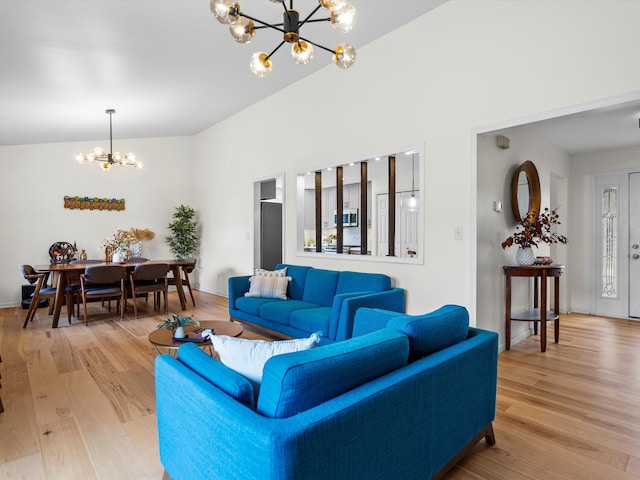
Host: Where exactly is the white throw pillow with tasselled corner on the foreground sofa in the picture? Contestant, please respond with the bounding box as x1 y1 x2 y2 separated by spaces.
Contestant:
209 333 320 394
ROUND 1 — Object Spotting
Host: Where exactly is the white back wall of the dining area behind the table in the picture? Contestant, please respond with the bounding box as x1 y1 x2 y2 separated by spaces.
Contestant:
0 137 193 307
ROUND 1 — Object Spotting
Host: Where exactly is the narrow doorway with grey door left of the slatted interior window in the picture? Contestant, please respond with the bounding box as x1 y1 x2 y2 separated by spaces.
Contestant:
253 175 284 270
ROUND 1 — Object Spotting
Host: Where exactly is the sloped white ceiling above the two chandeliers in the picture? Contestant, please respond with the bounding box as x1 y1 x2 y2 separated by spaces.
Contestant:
0 0 445 145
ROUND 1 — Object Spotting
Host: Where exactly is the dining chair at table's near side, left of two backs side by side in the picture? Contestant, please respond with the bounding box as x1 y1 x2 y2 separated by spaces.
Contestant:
80 265 126 325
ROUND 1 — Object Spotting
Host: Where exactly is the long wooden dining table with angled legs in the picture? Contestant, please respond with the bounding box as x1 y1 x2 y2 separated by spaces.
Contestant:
34 260 195 328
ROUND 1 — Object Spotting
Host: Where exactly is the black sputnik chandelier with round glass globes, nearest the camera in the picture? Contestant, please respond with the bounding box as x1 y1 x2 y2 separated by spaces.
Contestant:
210 0 356 77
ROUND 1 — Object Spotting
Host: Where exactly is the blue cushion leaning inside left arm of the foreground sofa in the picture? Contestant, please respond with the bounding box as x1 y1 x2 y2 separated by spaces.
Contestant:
178 343 255 410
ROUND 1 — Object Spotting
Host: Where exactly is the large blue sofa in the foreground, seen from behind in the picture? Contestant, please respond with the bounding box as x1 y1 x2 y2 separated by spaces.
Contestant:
155 306 498 480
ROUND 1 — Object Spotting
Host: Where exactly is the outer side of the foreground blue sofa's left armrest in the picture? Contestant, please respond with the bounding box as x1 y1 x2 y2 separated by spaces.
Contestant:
155 355 273 480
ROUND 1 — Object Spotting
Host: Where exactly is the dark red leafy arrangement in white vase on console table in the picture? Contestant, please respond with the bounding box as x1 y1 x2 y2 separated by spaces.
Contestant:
502 207 567 265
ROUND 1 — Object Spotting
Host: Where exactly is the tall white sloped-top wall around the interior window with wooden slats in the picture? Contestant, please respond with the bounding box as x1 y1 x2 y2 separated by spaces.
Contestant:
196 0 640 330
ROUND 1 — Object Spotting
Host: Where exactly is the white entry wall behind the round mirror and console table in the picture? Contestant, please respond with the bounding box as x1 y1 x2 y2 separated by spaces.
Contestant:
477 126 568 348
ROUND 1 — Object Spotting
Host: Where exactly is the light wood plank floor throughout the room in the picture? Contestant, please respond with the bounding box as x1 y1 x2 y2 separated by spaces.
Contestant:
0 292 640 480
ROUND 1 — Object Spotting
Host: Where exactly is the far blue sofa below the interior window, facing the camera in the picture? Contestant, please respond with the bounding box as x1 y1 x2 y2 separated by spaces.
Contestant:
229 264 404 344
